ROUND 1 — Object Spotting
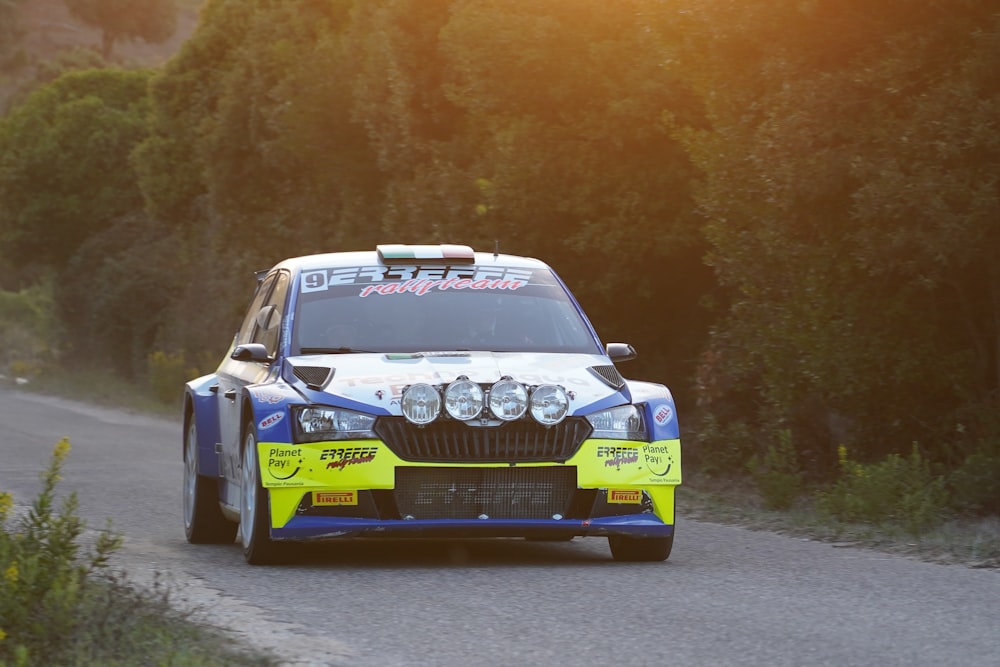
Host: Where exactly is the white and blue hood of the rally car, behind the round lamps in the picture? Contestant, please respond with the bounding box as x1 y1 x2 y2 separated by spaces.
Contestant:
288 352 629 414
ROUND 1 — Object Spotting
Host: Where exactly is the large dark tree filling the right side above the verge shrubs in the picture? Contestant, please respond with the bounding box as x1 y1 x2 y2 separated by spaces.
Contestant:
664 0 1000 473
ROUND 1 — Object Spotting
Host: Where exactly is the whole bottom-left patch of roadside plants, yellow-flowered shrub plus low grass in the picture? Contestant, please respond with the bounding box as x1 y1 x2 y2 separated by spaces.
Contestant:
0 439 277 667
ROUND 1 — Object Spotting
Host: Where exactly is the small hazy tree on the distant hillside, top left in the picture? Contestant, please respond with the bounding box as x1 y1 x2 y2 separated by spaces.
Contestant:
63 0 177 60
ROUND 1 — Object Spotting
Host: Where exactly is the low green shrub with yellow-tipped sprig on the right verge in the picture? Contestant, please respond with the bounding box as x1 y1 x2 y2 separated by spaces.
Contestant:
817 443 948 535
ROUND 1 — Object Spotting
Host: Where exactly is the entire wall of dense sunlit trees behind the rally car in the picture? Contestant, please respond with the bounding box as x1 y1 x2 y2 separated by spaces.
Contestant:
0 0 1000 509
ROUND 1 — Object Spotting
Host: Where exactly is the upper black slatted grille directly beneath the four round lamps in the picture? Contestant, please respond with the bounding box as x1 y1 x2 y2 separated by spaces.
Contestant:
375 417 593 463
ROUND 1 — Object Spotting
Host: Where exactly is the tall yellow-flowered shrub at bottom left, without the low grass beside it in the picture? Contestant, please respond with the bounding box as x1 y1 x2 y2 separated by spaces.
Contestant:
0 439 122 665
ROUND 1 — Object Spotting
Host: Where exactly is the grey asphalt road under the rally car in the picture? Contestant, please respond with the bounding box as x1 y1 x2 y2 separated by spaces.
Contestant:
0 389 1000 667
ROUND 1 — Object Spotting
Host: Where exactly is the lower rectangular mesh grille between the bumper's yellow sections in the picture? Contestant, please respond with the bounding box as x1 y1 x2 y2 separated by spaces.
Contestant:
394 466 576 519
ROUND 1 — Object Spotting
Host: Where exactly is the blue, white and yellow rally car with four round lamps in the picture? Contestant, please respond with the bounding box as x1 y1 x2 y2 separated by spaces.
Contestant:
183 245 681 564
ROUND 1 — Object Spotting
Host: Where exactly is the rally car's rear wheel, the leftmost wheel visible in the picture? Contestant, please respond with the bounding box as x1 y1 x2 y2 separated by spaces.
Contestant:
184 414 237 544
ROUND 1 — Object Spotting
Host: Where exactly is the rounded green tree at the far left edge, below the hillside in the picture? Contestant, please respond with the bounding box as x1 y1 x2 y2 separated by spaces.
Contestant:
0 69 150 267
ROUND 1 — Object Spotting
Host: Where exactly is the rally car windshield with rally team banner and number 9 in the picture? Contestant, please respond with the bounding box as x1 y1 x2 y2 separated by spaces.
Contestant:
291 266 601 354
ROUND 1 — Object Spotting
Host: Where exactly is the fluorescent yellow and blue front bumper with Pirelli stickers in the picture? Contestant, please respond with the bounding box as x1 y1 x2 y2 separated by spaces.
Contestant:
258 439 681 541
